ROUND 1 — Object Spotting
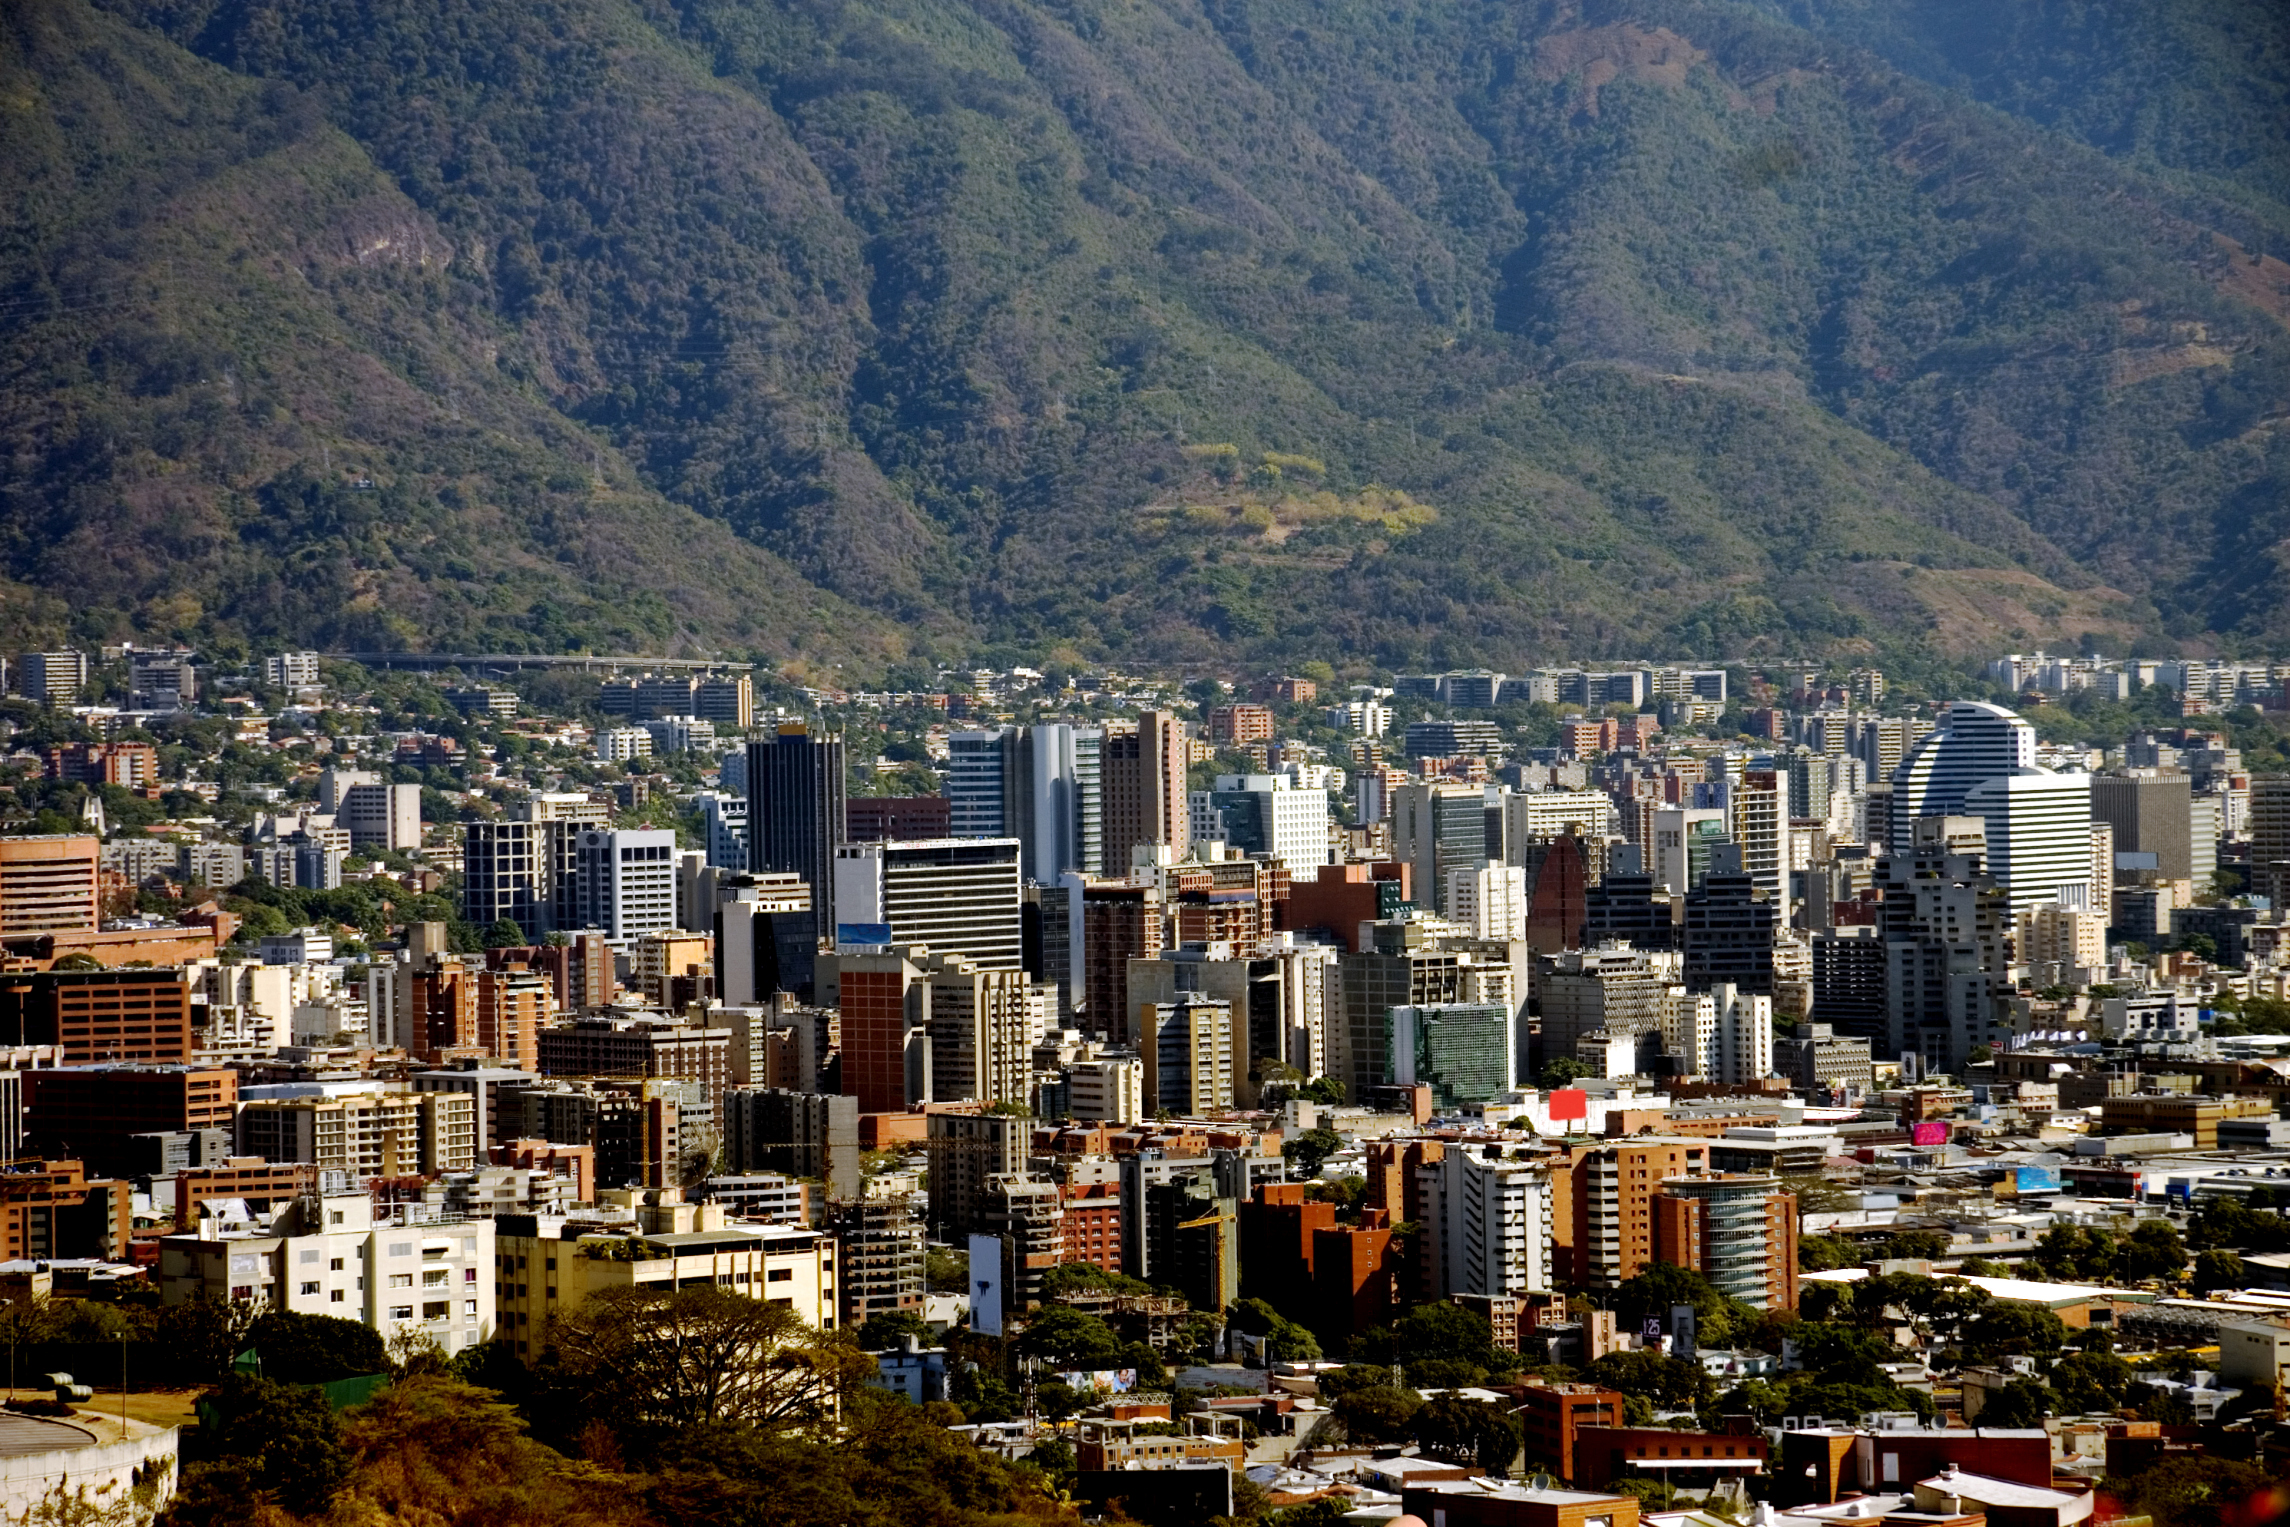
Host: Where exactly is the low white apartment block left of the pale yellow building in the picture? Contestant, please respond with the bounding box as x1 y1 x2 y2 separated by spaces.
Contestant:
160 1177 495 1353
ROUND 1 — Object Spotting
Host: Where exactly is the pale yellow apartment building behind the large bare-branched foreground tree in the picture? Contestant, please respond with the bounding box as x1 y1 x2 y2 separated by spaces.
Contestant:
495 1188 838 1360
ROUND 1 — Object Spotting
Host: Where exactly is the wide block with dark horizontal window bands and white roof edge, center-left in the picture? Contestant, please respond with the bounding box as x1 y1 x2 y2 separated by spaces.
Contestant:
834 838 1024 971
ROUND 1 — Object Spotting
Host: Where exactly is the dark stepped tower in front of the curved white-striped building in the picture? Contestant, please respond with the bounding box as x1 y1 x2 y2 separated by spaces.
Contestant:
1878 817 2011 1071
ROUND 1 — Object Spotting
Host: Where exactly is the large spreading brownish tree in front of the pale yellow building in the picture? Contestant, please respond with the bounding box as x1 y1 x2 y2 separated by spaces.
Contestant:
550 1284 875 1438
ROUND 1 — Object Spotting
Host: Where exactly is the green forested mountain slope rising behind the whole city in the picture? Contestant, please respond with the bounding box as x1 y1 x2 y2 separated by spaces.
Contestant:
0 0 2290 666
